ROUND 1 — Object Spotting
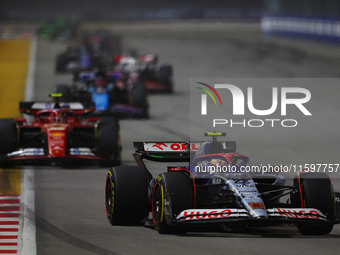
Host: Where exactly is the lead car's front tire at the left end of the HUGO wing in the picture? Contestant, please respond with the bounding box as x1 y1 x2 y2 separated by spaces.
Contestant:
152 172 193 234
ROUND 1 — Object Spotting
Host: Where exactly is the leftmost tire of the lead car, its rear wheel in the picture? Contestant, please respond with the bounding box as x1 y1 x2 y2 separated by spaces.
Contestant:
105 166 150 225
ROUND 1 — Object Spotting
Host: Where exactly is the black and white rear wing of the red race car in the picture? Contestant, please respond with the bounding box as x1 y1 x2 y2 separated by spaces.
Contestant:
19 102 95 114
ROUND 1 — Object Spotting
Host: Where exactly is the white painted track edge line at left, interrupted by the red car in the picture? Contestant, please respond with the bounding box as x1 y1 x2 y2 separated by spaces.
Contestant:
18 35 38 255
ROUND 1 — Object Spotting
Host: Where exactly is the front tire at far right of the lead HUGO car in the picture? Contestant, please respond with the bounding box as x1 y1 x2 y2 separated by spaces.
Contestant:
297 173 335 235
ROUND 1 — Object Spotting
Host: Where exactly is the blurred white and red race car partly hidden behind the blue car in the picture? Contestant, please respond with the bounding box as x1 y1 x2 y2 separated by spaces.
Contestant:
114 53 173 93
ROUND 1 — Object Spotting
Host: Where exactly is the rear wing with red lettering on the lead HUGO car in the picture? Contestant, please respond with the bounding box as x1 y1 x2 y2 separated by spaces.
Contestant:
133 141 236 164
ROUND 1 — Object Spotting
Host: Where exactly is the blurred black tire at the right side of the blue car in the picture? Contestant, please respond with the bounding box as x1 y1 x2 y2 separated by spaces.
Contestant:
131 82 149 118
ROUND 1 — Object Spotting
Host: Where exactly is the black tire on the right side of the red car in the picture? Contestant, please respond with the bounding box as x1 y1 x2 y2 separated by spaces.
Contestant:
98 117 121 167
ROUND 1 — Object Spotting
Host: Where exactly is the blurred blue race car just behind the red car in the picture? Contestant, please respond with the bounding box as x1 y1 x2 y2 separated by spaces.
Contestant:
54 70 149 118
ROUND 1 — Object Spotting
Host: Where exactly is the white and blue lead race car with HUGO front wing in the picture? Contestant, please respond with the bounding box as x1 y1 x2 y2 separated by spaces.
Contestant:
105 133 340 235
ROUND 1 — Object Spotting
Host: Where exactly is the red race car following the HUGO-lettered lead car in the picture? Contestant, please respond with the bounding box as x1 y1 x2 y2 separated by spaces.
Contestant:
0 95 121 166
